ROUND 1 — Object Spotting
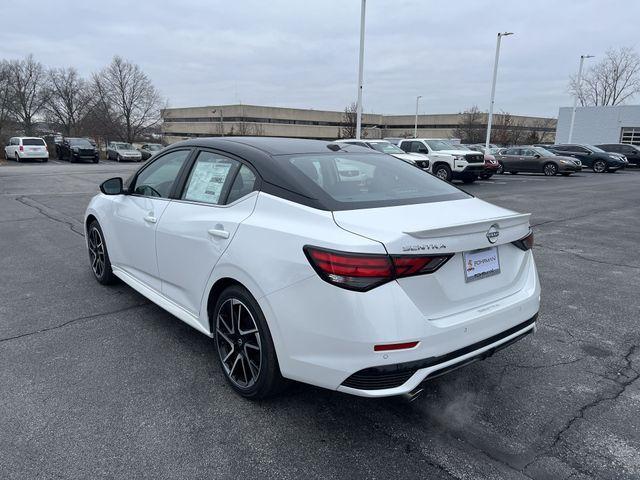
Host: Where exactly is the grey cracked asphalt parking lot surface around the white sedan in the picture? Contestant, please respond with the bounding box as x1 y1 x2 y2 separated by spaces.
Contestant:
0 161 640 479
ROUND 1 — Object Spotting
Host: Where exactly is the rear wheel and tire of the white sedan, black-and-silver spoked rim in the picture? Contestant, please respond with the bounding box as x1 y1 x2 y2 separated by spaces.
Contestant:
212 285 286 400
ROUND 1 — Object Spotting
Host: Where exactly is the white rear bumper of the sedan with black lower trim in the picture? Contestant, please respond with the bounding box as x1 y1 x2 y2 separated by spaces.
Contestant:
258 247 540 397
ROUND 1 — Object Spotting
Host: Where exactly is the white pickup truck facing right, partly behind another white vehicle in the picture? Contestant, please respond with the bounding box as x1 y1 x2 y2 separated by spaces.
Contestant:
398 138 484 183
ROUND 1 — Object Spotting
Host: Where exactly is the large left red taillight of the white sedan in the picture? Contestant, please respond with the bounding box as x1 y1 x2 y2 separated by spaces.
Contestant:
304 246 453 292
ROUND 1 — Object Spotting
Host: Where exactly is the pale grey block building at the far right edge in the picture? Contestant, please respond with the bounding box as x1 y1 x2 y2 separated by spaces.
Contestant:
556 105 640 145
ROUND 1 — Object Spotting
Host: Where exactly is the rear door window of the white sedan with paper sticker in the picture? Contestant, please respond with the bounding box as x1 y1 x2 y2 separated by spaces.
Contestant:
182 151 239 205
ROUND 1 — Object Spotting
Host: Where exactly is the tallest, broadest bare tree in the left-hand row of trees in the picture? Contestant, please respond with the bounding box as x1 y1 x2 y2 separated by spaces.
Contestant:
93 56 163 142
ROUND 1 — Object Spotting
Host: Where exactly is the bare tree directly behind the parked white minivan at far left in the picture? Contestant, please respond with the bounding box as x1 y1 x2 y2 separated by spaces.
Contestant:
9 55 47 135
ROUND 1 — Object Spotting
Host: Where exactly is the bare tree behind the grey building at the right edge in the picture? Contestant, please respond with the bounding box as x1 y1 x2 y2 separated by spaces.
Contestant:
569 47 640 106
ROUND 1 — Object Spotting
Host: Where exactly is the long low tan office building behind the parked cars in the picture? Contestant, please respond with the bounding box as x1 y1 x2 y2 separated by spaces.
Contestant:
162 105 555 144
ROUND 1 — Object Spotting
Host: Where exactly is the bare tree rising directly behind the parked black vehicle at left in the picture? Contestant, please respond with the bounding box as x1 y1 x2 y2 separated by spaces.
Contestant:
45 68 90 135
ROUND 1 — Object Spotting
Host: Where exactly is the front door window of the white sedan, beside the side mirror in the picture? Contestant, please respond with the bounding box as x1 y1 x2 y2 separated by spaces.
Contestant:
133 150 191 198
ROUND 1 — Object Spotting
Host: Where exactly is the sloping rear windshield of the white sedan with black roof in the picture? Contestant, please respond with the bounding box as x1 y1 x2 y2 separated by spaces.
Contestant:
289 153 469 210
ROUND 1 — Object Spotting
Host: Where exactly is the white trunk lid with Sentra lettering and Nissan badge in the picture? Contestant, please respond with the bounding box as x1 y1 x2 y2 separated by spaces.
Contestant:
333 198 530 320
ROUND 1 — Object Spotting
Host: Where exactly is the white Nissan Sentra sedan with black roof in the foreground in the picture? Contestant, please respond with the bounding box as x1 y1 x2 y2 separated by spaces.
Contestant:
85 137 540 398
